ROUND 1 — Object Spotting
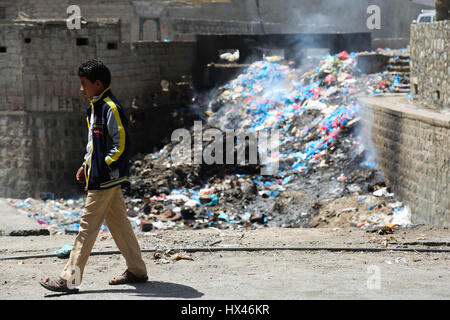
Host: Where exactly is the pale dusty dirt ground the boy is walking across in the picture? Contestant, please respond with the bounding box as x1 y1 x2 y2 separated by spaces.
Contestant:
0 226 450 300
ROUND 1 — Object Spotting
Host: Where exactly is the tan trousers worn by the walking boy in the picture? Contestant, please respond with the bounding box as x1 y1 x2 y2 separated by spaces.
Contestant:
61 185 147 286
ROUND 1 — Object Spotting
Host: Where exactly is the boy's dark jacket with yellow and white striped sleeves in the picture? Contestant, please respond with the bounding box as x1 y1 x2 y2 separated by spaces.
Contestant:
83 88 130 190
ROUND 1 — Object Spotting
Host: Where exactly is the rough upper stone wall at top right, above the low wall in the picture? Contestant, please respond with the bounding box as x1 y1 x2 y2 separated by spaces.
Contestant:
410 21 450 110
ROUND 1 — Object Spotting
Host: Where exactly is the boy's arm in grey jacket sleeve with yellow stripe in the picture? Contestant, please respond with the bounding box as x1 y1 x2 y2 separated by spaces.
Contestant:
105 101 125 166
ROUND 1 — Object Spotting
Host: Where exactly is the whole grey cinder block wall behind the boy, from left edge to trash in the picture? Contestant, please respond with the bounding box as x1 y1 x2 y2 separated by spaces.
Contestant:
0 20 196 197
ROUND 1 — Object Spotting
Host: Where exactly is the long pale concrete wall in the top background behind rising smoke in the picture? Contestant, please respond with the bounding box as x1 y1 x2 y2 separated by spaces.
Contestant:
160 0 428 46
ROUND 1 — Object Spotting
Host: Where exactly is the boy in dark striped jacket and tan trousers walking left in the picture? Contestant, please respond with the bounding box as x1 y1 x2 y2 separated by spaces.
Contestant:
40 59 148 293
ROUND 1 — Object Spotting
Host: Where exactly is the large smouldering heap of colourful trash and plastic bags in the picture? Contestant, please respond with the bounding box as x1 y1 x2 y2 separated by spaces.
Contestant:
124 51 410 231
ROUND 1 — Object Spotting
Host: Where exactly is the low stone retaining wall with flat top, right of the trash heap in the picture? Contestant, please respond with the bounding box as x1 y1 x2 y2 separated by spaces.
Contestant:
359 97 450 227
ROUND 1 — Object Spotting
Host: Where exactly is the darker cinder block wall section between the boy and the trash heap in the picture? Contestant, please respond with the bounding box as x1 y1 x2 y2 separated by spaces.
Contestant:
102 41 197 153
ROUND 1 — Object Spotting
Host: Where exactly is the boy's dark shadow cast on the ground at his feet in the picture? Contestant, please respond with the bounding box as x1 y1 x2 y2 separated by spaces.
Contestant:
45 281 204 299
